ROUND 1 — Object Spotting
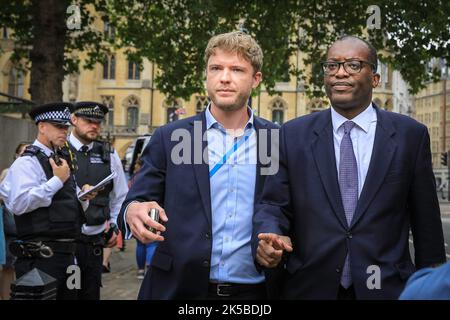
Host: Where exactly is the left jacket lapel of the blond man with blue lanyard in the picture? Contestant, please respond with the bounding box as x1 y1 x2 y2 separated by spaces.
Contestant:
190 111 211 226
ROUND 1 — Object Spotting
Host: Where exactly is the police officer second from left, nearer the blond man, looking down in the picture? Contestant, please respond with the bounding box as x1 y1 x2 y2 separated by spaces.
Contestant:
69 101 128 300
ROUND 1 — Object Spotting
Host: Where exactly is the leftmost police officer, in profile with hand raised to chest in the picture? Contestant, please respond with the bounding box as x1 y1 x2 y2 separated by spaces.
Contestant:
0 102 95 299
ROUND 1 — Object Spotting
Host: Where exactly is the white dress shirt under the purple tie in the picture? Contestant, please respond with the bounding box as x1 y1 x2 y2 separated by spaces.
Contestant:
331 104 377 197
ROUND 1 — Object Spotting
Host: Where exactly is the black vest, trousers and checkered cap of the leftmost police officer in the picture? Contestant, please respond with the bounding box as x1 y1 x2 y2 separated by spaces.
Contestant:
13 103 84 300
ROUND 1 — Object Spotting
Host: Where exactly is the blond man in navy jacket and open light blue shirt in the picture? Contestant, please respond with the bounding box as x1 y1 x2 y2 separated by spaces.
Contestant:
118 32 278 299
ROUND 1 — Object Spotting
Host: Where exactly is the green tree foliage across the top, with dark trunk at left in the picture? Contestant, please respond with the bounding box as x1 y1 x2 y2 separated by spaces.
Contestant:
0 0 450 102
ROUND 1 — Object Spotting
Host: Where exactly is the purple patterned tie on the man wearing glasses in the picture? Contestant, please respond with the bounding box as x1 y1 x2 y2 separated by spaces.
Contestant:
339 121 358 288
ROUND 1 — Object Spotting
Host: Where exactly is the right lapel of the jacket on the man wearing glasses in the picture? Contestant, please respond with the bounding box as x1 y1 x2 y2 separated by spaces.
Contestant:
351 105 397 226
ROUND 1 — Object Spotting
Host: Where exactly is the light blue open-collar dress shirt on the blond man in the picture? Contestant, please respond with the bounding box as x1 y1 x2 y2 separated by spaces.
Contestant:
206 107 264 283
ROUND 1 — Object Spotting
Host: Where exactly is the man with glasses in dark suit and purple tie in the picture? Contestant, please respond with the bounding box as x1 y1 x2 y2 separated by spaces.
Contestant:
252 36 445 299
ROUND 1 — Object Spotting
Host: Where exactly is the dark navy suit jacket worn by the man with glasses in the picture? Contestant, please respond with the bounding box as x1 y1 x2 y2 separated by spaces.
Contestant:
252 108 445 299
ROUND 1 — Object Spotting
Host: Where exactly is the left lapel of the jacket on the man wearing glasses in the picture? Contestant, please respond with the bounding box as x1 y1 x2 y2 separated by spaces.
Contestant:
311 109 347 228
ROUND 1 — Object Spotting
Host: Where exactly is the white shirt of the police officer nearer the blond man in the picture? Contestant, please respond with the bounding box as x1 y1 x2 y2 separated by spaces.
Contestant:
69 132 128 235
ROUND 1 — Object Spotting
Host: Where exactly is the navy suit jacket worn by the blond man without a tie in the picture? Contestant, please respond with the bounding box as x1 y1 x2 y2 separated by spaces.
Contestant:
118 112 278 299
